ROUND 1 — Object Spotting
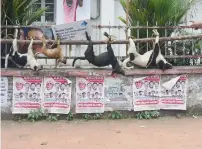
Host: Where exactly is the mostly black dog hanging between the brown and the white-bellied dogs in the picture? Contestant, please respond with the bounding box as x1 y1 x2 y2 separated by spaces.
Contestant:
72 32 125 75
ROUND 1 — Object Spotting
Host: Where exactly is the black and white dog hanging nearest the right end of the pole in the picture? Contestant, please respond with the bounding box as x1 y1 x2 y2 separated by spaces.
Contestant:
121 30 172 71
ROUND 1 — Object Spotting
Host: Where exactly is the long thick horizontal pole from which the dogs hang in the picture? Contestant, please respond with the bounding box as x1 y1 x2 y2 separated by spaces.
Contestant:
0 34 202 45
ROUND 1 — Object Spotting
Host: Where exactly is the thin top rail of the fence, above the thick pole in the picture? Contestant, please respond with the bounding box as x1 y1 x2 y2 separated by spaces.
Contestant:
1 25 196 29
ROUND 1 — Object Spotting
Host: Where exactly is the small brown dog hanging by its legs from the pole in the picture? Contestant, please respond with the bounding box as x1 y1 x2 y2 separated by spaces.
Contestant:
35 37 67 65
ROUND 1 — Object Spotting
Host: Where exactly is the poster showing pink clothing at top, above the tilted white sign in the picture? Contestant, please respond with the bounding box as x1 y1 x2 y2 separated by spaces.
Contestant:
63 0 91 23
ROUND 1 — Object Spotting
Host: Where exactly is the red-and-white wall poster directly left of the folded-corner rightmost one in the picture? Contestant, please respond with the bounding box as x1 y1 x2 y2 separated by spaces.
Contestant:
133 75 160 111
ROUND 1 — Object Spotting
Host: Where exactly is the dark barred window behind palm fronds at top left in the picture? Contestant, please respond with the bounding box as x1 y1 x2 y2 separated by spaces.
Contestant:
34 0 55 23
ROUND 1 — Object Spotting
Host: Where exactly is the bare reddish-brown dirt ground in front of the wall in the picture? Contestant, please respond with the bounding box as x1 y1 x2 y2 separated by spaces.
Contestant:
1 117 202 149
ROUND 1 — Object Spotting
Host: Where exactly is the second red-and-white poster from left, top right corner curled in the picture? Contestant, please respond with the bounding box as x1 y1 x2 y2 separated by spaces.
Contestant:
43 76 72 114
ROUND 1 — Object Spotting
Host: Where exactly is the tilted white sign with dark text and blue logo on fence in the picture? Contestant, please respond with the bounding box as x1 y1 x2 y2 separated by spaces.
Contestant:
52 20 92 40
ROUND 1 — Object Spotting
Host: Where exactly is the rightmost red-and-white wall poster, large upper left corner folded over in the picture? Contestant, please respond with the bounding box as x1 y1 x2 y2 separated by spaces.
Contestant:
160 75 188 110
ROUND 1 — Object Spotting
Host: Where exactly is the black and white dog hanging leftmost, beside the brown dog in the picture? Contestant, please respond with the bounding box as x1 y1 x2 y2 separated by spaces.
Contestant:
5 30 42 71
